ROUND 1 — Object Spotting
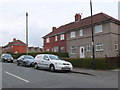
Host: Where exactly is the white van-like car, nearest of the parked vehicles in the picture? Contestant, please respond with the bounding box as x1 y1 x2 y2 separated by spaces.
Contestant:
34 54 73 71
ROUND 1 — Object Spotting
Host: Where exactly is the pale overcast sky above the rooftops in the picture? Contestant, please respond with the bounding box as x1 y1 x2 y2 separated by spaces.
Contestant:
0 0 119 47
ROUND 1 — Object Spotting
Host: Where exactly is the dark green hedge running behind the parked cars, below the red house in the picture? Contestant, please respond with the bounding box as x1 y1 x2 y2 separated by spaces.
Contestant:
11 52 69 59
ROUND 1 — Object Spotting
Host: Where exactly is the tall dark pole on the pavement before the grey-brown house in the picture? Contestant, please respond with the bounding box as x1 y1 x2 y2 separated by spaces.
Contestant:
90 0 96 70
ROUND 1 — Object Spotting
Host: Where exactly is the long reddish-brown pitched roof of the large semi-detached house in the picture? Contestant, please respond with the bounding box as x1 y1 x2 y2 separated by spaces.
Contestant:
43 12 120 38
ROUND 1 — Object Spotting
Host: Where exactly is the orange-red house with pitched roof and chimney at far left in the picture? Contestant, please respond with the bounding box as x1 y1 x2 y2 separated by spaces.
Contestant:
2 38 27 53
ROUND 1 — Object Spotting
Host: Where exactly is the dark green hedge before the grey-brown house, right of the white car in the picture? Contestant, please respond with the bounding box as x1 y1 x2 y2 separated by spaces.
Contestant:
64 58 118 70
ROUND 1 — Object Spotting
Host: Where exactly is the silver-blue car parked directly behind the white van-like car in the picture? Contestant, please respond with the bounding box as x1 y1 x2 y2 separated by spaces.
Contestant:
17 55 34 66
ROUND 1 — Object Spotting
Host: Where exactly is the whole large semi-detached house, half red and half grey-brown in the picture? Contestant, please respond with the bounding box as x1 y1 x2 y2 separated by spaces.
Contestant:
43 13 120 58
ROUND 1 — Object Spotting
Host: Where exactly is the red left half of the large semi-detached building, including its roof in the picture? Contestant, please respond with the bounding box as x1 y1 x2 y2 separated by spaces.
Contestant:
43 26 67 52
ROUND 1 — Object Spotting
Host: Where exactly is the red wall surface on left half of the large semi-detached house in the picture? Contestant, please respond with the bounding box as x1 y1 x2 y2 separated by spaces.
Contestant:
44 34 67 52
